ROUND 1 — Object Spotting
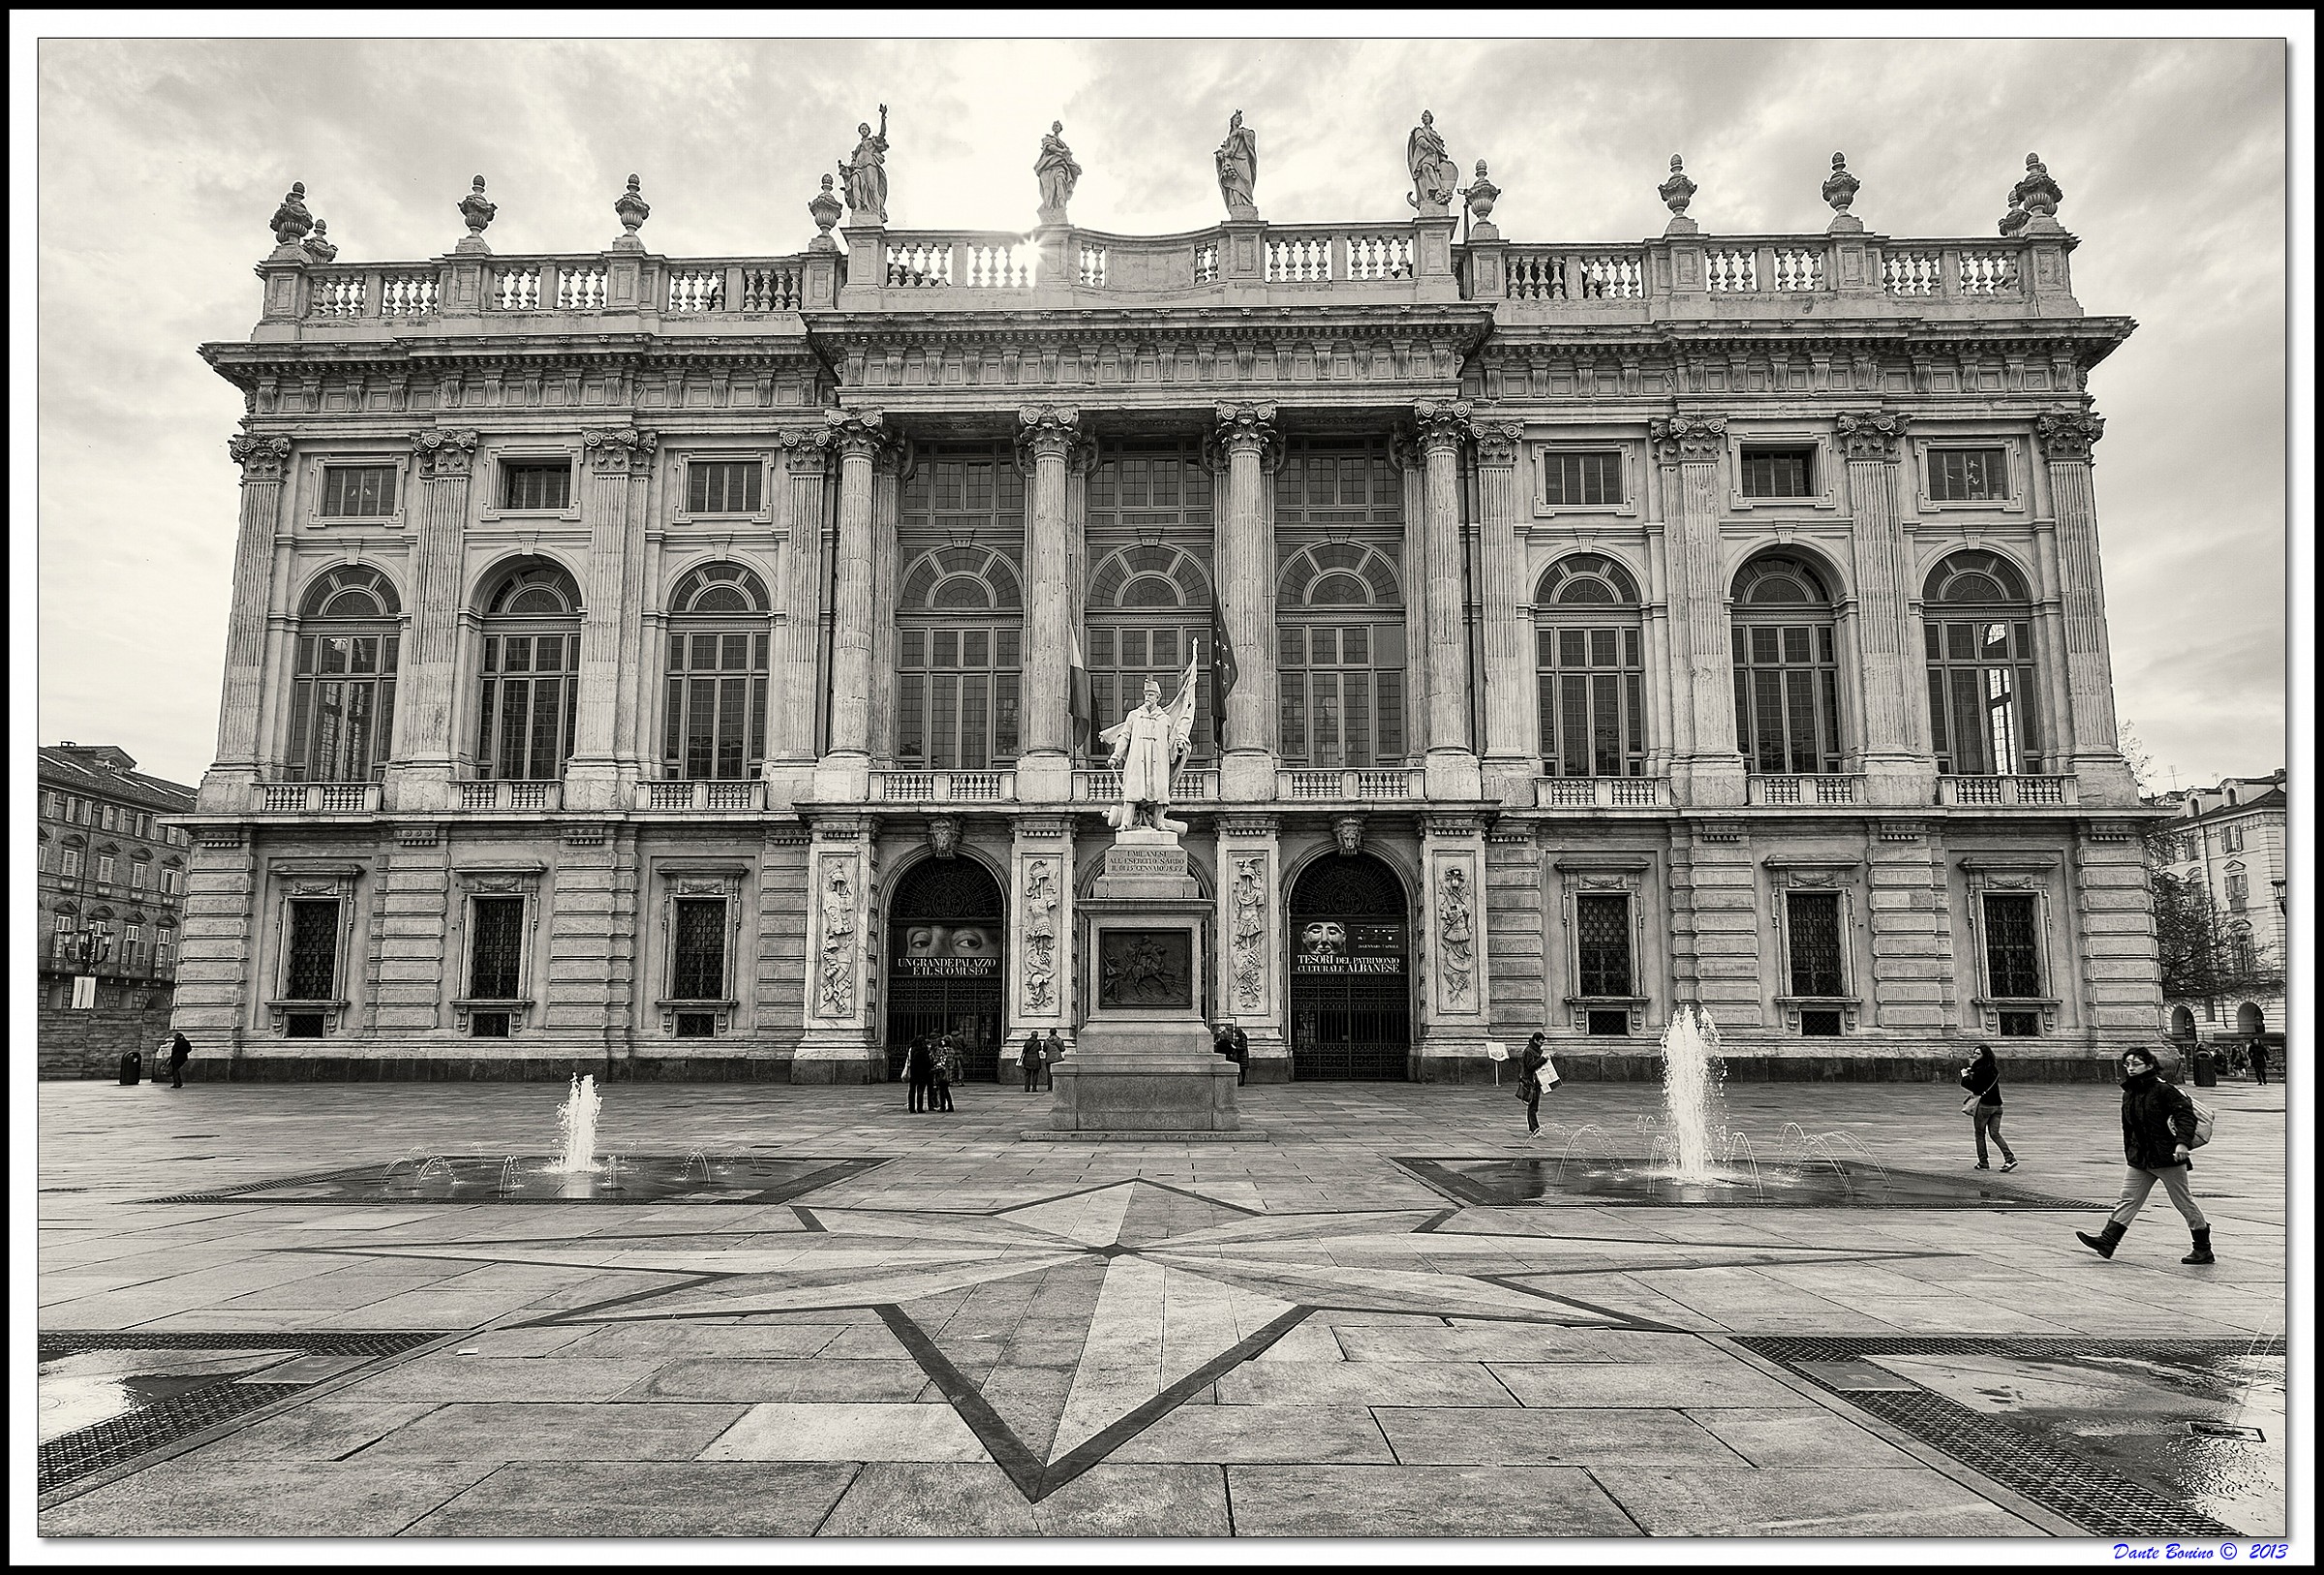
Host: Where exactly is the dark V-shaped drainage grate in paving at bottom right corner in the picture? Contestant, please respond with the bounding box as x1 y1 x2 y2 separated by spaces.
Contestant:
1731 1334 2284 1538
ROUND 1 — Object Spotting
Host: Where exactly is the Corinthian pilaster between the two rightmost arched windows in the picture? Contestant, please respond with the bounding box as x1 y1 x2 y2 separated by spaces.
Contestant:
1834 411 1936 804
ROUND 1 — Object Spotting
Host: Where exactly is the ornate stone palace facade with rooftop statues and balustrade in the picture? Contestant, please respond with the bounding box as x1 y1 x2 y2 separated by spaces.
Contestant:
176 118 2161 1083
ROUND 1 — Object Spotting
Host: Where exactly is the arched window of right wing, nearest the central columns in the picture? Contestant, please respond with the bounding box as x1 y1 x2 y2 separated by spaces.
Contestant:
1534 553 1645 776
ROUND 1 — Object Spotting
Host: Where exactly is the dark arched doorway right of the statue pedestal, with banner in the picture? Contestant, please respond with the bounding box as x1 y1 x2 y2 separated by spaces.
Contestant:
1290 852 1413 1078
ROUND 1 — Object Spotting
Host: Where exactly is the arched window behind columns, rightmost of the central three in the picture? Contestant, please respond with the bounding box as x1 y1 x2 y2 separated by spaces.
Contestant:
1276 541 1406 766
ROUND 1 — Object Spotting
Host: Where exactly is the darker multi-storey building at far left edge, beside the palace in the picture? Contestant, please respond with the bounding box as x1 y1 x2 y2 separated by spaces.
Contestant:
35 741 193 1012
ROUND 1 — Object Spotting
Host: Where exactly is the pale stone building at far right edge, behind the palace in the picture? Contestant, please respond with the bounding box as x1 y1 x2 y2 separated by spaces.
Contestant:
2155 769 2291 1066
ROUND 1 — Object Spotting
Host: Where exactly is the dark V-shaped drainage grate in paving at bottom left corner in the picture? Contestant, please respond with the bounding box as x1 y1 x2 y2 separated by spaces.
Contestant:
40 1331 442 1494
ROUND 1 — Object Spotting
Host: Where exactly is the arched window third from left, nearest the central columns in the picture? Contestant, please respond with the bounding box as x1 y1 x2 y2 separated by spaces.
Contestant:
662 562 769 781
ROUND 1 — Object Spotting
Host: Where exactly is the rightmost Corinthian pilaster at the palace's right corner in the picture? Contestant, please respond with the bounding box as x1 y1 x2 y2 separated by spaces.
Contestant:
2034 411 2138 804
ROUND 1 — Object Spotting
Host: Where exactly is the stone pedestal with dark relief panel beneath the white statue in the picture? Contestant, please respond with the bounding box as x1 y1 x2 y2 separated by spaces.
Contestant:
1048 829 1243 1136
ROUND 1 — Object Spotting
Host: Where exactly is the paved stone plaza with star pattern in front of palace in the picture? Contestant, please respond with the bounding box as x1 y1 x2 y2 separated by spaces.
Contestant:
40 1083 2284 1538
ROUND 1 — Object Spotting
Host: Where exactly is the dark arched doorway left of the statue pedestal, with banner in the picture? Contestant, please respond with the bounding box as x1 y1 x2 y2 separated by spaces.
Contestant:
888 857 1009 1083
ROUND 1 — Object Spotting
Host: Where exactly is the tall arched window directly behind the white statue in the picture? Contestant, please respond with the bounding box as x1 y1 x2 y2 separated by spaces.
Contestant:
1087 543 1215 762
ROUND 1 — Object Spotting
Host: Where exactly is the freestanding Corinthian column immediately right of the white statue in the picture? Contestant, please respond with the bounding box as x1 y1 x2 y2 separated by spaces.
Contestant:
1218 404 1276 801
